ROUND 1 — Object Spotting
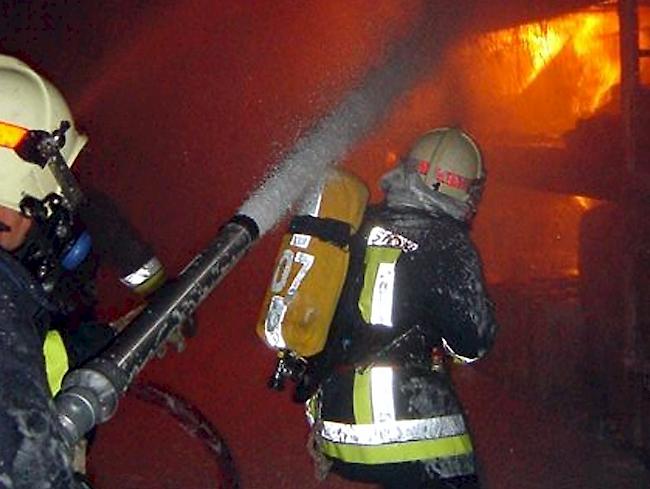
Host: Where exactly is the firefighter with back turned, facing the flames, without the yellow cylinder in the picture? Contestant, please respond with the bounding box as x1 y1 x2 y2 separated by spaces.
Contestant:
295 128 497 489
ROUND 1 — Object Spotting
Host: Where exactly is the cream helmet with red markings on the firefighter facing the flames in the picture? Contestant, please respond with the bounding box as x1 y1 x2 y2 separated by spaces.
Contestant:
407 127 485 202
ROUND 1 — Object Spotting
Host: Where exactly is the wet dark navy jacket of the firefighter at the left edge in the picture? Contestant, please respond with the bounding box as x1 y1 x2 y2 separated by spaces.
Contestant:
0 250 78 489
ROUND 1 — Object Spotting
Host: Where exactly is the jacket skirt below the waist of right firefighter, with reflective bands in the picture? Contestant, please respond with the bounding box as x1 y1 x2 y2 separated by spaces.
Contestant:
310 366 474 476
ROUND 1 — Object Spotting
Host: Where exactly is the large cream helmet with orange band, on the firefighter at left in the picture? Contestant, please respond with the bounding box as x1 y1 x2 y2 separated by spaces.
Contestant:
0 55 88 211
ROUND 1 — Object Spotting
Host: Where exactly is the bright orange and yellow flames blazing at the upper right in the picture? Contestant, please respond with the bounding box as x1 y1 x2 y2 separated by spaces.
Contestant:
455 6 650 136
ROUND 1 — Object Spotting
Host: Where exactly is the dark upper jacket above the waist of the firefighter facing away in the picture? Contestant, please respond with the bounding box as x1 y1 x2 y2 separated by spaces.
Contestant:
332 204 497 364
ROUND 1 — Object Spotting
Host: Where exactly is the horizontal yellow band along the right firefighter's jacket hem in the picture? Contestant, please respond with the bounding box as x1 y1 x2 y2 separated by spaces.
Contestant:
321 434 474 465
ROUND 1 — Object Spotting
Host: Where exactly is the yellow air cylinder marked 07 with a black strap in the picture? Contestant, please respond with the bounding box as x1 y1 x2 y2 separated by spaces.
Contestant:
256 168 369 357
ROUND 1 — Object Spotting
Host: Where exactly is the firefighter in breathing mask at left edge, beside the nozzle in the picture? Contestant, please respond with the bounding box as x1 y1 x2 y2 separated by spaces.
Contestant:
0 55 170 489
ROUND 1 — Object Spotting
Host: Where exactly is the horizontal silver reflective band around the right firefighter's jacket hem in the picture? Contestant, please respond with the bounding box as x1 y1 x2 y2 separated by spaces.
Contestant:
321 414 467 445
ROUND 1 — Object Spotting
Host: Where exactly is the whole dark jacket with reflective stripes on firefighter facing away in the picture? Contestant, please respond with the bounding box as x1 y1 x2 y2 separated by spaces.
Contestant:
308 207 494 478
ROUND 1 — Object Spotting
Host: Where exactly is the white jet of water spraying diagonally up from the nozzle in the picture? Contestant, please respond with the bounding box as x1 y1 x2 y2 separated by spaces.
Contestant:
239 2 449 235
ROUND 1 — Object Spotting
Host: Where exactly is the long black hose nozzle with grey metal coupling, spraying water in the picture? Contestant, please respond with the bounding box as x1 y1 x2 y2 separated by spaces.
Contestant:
55 216 258 445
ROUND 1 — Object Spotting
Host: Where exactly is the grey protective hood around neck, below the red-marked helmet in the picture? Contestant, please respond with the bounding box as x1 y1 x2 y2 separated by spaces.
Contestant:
379 165 475 222
